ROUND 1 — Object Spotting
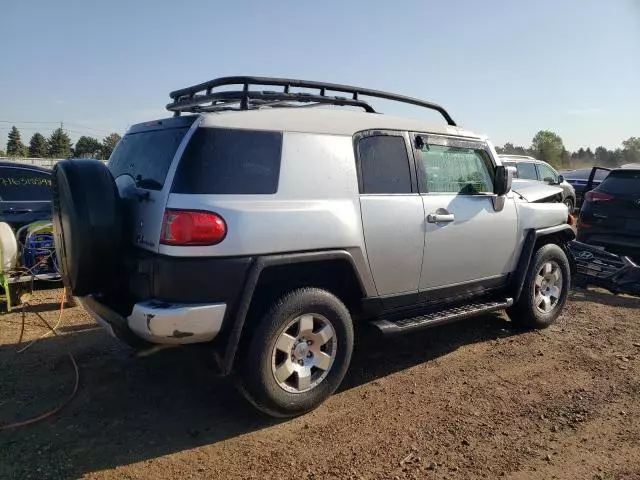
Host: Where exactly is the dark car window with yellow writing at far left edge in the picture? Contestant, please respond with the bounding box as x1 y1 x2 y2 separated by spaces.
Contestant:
0 167 51 202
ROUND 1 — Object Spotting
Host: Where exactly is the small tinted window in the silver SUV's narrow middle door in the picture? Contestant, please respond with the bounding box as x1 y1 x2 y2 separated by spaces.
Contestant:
358 135 411 193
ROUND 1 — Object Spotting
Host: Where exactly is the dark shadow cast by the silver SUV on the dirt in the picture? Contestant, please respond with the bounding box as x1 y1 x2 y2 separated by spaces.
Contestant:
0 315 517 478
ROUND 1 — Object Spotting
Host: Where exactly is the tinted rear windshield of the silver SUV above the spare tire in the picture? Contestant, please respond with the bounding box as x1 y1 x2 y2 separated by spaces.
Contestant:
109 127 189 190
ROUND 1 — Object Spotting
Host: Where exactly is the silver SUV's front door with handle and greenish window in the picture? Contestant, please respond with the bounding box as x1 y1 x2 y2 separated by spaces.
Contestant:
413 134 518 294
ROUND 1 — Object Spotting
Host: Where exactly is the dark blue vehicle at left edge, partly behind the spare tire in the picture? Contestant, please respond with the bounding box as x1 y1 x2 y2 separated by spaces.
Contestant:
0 162 51 230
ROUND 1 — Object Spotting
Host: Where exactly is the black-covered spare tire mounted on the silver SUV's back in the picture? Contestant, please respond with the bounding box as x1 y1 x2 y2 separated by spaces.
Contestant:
52 160 123 297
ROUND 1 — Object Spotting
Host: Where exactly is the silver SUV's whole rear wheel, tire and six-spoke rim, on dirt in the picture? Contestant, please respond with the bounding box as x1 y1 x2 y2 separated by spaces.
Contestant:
238 288 353 417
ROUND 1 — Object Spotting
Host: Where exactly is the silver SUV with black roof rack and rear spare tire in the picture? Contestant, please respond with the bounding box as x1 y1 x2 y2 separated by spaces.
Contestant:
53 77 574 416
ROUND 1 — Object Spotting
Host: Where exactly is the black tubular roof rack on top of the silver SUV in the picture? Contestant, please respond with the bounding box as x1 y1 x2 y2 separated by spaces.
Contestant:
167 76 456 126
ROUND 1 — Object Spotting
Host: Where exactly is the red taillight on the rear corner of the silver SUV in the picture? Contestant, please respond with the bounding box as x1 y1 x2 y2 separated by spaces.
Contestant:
160 210 227 246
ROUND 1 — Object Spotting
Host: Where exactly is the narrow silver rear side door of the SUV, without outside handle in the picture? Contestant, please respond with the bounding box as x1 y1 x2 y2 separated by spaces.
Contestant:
355 131 424 306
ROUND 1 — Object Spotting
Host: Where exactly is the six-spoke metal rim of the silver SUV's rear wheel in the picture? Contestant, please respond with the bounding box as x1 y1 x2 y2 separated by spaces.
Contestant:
271 313 338 393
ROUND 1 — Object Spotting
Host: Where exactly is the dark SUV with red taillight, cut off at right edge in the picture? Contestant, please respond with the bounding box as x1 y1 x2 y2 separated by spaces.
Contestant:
578 164 640 262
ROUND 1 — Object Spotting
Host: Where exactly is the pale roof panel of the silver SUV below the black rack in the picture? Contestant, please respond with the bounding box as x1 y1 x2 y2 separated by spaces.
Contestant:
202 107 484 139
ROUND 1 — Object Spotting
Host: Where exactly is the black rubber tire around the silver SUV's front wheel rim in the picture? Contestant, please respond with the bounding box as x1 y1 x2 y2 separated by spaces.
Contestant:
507 244 571 329
